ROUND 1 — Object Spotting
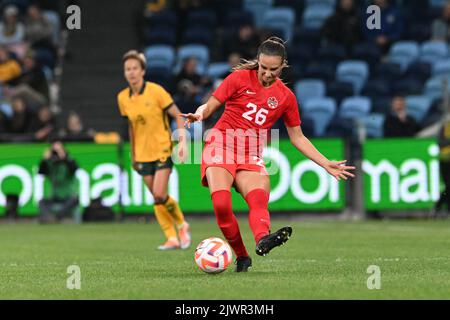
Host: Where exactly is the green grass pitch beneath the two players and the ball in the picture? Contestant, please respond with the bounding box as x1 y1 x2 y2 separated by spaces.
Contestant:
0 218 450 300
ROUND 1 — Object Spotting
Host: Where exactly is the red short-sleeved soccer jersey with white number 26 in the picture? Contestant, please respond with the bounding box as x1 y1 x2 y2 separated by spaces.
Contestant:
212 70 301 131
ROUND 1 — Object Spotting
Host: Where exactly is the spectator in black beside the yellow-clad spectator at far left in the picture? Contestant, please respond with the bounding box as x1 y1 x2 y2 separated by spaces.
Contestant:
18 51 49 101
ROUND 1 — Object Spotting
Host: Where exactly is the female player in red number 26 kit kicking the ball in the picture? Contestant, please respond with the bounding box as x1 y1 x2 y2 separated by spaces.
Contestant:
181 37 354 272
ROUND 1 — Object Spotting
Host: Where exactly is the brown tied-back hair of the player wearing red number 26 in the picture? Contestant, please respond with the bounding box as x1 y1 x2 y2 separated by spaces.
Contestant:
233 37 288 71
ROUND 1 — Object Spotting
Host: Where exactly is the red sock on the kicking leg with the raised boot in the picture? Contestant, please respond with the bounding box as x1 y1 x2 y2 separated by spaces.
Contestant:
245 189 270 243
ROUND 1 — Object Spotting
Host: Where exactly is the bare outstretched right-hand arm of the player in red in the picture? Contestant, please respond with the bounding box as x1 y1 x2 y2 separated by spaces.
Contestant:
287 126 355 180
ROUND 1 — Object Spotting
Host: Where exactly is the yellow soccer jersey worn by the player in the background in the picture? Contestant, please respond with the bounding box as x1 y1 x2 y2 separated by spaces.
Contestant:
117 82 173 162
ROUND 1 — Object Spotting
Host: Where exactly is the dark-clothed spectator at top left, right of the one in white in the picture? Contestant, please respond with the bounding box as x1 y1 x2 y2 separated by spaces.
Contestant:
25 5 53 47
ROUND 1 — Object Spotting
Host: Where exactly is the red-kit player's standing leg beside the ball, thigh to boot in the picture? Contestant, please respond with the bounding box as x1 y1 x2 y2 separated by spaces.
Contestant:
206 167 251 272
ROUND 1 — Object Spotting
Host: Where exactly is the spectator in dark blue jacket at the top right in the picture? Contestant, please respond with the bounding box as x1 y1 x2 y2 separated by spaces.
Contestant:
362 0 404 54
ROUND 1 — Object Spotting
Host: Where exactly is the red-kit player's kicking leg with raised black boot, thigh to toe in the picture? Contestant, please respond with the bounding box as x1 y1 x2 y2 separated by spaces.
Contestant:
236 170 292 256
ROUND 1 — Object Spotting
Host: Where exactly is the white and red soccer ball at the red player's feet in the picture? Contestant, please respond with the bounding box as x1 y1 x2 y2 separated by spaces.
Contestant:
195 237 233 273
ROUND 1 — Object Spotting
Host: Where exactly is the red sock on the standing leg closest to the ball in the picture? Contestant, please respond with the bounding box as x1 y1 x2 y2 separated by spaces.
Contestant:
211 190 248 257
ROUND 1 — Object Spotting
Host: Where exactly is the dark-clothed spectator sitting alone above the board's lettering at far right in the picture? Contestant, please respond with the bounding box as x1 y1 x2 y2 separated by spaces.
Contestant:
384 95 420 137
